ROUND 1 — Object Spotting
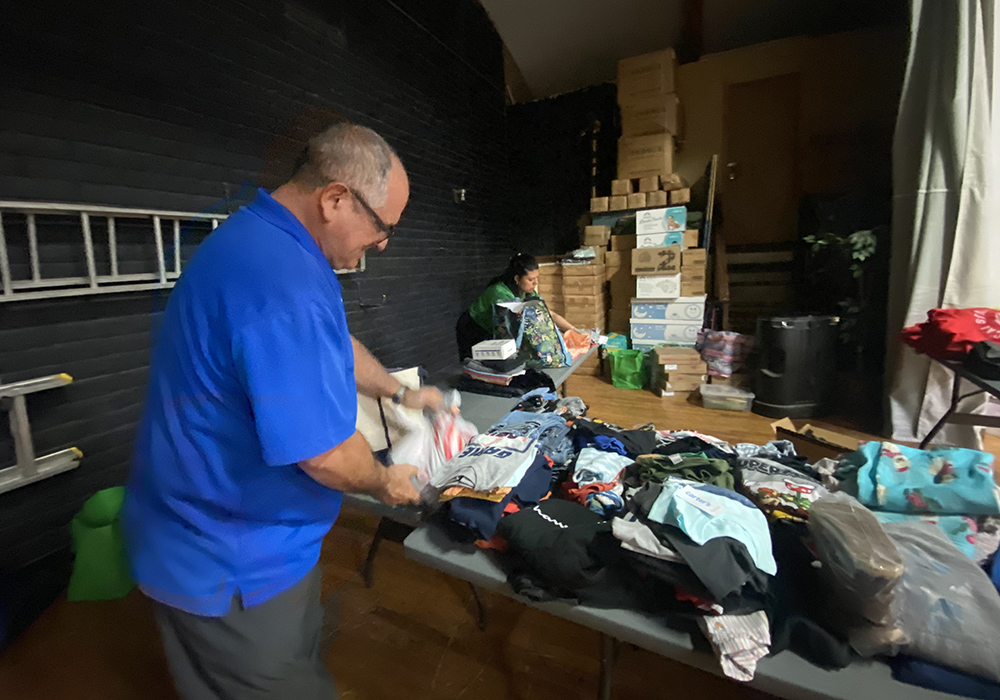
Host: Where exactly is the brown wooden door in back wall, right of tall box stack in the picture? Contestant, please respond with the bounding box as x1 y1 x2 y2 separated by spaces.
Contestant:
719 73 800 245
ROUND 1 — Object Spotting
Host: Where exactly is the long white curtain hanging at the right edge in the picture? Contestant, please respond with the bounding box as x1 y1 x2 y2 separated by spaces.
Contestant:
887 0 1000 447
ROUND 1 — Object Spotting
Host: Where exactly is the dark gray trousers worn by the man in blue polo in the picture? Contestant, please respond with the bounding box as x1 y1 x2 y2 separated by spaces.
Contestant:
156 565 337 700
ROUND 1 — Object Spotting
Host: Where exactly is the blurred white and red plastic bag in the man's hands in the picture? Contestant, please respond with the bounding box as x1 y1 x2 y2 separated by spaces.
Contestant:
389 404 479 489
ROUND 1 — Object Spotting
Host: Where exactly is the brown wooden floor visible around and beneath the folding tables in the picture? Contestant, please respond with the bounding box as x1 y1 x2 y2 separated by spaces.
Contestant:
0 377 1000 700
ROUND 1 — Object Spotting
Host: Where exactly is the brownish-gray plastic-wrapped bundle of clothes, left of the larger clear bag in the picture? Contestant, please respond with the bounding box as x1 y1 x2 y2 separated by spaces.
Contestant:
808 492 903 627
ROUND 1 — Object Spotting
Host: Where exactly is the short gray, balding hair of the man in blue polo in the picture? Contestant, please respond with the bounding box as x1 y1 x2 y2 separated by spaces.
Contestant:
292 122 398 207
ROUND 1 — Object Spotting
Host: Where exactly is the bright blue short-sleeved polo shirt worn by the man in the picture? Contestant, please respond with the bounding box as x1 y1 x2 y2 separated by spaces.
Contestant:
123 190 357 616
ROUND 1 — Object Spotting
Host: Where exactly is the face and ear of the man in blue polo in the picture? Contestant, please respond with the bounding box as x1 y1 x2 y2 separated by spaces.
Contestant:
312 161 410 270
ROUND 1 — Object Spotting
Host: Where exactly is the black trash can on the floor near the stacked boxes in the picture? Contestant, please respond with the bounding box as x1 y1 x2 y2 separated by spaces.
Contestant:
753 316 840 418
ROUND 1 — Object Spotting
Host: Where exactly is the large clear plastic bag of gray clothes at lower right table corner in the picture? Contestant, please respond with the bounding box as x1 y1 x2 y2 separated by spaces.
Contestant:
868 522 1000 682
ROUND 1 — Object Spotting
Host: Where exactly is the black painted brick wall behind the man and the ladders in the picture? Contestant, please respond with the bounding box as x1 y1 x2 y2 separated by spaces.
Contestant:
0 0 509 580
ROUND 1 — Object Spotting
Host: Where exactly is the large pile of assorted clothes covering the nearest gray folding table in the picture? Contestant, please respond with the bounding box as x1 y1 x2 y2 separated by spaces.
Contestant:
422 389 1000 697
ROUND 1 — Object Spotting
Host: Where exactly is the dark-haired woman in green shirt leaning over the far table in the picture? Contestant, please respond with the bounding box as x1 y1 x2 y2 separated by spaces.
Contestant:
455 253 573 360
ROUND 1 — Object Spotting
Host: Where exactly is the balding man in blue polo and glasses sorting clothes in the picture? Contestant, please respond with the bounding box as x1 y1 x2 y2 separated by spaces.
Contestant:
124 125 443 700
